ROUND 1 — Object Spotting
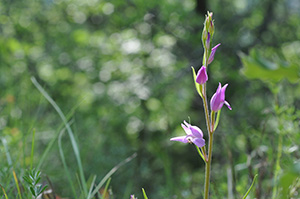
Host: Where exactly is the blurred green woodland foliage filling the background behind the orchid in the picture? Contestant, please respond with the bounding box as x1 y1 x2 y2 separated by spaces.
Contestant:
0 0 300 199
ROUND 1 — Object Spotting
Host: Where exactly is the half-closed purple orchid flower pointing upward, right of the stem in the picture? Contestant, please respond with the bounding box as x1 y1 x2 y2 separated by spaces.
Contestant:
210 83 231 112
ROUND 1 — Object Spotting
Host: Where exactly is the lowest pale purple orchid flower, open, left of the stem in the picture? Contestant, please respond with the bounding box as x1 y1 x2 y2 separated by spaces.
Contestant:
170 121 205 148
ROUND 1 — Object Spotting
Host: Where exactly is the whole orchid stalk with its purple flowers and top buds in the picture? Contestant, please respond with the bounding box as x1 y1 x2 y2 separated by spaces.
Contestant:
171 12 231 199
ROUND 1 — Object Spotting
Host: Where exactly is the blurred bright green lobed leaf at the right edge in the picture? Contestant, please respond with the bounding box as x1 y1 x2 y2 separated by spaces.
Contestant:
238 49 300 83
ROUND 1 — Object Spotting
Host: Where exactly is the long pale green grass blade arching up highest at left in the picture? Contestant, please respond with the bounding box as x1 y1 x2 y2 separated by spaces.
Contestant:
31 77 88 196
